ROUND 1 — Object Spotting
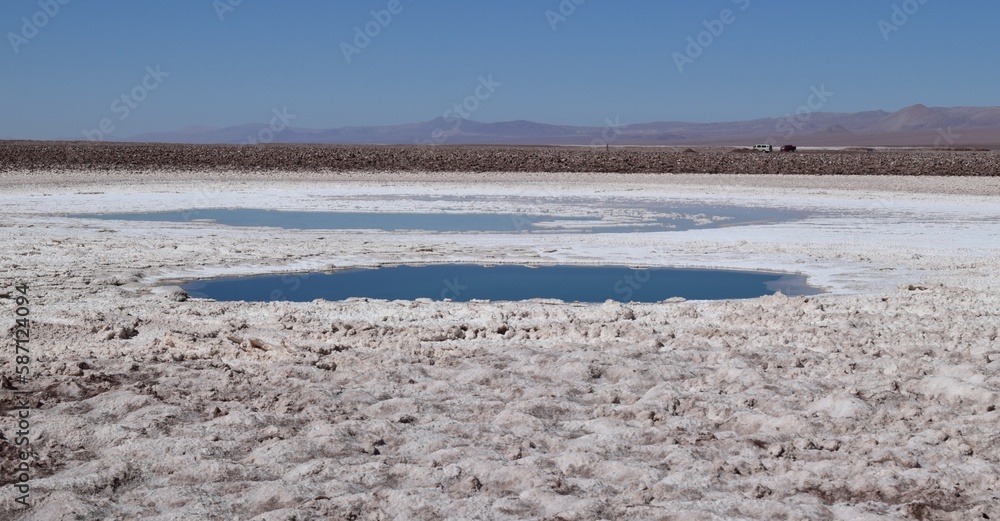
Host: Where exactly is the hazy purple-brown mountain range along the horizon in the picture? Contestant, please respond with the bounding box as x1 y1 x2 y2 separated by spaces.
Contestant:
122 105 1000 146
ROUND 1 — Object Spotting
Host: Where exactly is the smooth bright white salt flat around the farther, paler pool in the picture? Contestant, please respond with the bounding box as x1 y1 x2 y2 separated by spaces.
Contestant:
5 175 1000 294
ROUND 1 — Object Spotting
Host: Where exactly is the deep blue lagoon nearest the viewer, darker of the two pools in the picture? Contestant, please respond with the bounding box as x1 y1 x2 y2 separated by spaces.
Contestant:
183 264 820 302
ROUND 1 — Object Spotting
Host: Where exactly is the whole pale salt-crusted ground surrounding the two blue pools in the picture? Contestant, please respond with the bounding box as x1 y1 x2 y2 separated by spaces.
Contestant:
0 171 1000 520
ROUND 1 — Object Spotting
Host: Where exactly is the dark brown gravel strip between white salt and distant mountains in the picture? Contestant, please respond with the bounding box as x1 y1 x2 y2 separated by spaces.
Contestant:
0 141 1000 176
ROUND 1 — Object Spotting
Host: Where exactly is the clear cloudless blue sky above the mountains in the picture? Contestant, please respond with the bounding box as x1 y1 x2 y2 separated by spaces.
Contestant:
0 0 1000 139
